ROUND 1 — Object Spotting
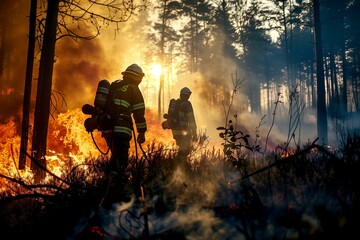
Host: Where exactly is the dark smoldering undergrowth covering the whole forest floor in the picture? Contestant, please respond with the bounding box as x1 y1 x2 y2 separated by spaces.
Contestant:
0 132 360 239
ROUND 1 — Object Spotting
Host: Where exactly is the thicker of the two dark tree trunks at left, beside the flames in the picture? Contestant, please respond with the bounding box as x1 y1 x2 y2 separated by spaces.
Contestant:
31 0 59 182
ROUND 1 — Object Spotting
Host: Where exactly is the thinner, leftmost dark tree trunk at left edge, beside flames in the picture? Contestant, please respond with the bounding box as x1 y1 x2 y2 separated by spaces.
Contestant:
19 0 37 169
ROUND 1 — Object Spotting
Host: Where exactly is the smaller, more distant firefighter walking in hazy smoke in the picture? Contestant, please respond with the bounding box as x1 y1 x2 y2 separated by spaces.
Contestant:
162 87 197 160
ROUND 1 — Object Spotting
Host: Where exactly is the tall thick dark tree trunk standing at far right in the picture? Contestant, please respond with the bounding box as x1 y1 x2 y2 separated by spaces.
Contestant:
313 0 328 143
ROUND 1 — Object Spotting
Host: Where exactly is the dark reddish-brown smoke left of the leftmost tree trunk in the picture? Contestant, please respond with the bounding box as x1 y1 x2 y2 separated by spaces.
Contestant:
0 0 30 122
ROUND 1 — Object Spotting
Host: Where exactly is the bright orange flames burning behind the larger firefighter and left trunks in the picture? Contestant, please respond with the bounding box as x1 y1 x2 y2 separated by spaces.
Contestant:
0 108 174 192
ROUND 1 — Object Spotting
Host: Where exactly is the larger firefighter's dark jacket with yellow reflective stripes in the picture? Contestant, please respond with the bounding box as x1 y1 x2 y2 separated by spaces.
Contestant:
106 78 147 139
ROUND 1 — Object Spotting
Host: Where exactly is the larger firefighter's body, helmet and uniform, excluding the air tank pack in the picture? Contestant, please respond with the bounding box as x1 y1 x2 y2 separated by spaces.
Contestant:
103 64 147 204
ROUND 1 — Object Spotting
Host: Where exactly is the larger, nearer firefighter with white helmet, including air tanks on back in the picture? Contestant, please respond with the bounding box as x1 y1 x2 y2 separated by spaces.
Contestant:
83 64 147 205
